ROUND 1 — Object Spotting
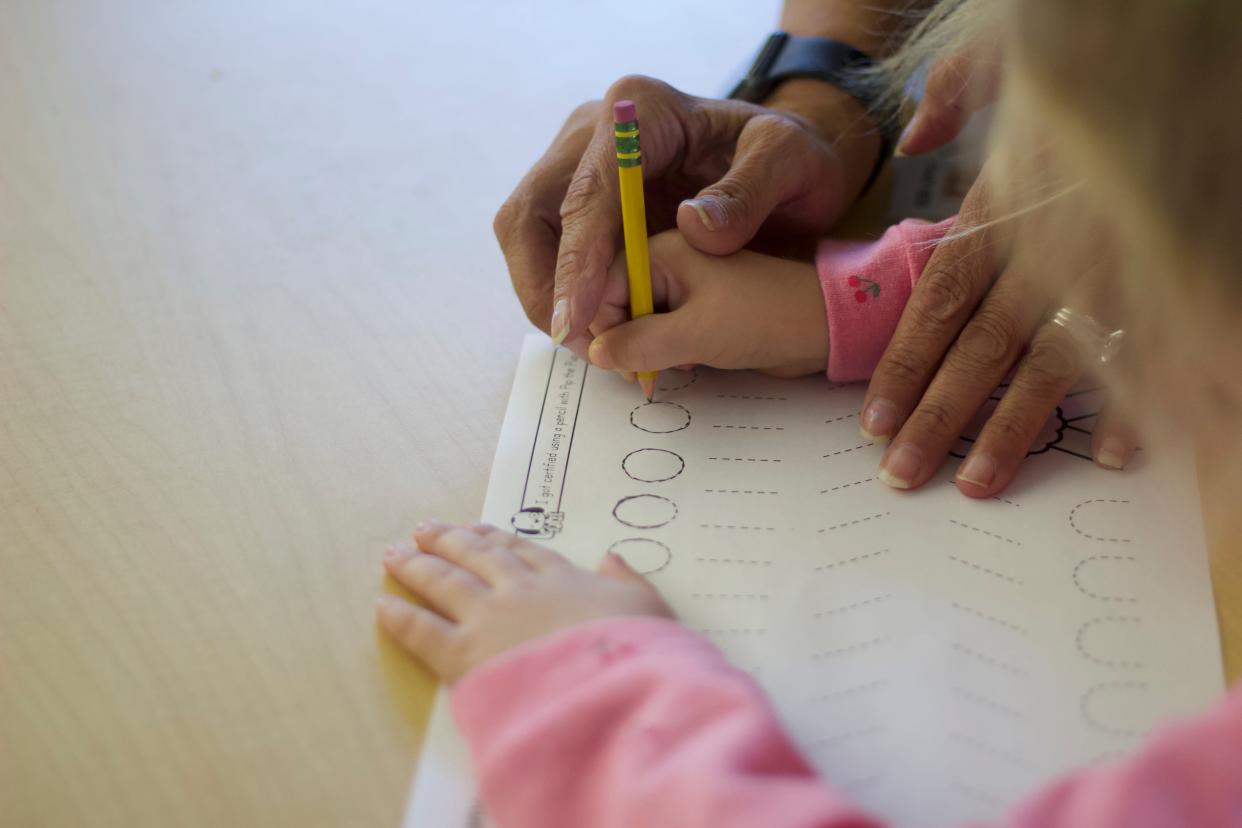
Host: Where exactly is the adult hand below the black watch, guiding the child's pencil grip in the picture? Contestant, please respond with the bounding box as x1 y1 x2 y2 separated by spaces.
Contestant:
494 76 879 353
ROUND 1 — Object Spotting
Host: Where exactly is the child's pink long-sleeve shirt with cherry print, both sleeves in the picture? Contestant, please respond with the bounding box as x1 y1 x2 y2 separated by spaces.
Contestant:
452 220 1242 828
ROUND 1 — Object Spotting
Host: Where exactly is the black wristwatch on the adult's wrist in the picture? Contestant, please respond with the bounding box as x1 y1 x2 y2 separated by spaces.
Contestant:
729 31 898 192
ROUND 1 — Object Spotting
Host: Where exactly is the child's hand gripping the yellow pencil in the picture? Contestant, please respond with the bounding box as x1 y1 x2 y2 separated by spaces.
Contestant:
589 231 828 376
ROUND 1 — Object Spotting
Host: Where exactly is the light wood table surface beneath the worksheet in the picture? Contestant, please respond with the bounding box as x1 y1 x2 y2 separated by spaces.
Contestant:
0 0 1242 828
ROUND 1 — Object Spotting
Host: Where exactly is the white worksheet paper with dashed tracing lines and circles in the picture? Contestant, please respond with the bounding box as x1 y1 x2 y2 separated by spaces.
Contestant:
406 336 1223 828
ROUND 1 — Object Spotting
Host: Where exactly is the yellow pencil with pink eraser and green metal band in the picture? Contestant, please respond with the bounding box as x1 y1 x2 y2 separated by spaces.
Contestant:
612 101 656 401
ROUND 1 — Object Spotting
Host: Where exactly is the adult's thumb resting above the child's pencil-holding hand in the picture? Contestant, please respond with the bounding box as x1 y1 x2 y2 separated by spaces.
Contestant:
677 115 809 256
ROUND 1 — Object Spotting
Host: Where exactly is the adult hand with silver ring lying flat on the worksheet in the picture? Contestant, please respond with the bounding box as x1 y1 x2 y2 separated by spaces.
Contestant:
859 178 1135 498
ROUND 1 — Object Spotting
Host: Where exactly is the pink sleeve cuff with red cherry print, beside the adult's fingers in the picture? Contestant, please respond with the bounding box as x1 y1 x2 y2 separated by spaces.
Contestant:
815 216 956 382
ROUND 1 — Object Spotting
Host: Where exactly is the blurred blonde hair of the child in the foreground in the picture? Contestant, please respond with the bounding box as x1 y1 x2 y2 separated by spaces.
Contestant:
887 0 1242 434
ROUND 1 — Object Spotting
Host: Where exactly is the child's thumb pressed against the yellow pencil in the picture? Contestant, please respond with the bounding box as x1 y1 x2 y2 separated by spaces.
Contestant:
587 310 705 371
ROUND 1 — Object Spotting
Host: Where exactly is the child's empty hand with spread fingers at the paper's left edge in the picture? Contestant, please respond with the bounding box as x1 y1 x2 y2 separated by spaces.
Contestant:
378 521 673 683
